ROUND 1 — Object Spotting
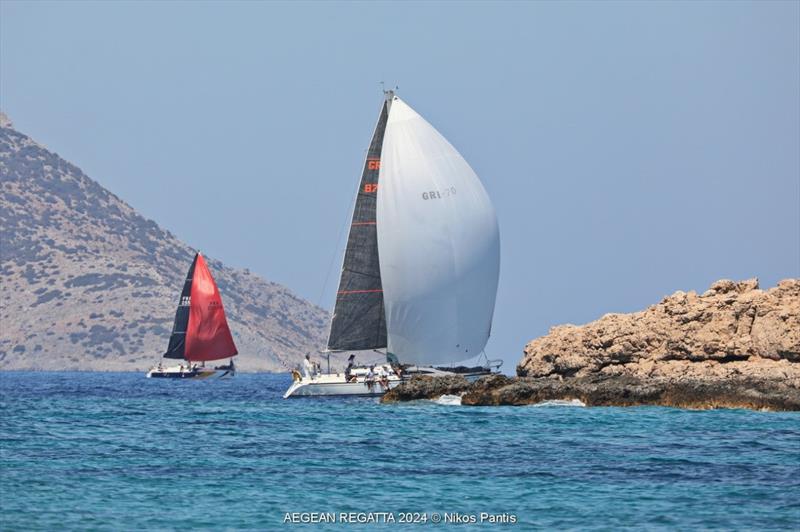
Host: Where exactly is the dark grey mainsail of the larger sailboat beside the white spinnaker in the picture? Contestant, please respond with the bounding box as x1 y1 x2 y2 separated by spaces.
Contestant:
328 98 390 351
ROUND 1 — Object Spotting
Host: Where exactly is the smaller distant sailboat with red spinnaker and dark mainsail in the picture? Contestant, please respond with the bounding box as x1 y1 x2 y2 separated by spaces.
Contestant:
147 252 238 379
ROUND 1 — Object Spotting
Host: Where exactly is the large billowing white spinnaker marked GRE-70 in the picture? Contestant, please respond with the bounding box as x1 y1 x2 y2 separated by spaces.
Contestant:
377 97 500 365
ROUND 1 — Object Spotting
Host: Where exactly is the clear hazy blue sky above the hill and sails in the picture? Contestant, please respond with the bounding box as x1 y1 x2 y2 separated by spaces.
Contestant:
0 0 800 366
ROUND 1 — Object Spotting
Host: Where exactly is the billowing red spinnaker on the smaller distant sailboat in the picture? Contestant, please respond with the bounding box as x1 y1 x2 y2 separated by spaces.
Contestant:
184 254 238 361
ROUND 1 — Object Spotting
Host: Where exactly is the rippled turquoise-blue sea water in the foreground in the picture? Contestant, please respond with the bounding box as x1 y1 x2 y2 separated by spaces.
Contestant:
0 372 800 530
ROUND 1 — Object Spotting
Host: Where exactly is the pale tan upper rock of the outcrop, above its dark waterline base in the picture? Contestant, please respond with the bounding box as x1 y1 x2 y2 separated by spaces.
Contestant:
517 279 800 386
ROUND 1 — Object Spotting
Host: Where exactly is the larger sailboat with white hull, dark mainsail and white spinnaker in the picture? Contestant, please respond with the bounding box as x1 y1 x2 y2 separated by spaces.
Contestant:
284 91 500 398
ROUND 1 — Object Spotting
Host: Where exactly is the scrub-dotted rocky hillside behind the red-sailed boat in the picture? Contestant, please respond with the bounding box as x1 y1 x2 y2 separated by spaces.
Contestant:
0 115 328 371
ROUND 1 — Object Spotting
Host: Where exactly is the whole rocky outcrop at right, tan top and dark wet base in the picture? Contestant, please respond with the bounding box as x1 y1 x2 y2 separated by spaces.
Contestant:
383 279 800 410
